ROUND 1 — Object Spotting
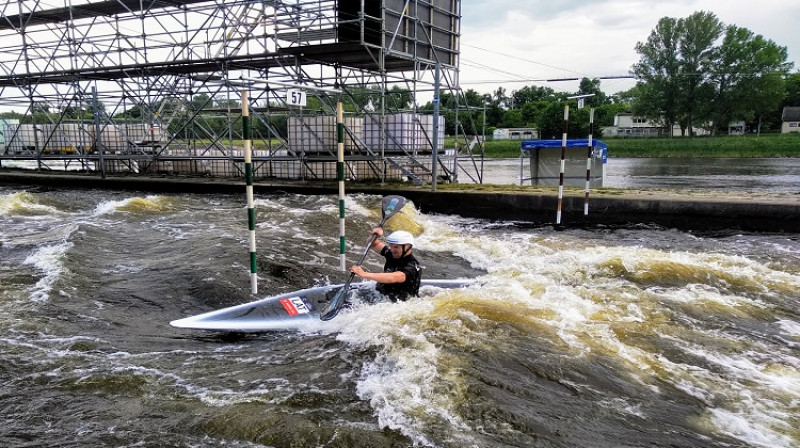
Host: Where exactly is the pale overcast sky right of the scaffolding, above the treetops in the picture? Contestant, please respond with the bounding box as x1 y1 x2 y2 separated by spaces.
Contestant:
460 0 800 98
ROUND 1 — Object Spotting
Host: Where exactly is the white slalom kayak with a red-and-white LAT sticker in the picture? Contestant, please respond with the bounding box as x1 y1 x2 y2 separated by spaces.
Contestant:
170 279 475 332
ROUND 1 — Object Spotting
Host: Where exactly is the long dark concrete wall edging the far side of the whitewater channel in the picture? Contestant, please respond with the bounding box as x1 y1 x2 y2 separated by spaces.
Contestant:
0 171 800 232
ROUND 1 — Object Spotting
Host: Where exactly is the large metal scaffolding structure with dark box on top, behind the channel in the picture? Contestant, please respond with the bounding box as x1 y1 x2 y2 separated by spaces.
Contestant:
0 0 482 183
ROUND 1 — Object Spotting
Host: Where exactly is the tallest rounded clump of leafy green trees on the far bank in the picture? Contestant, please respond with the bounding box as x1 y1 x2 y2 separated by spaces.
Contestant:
630 12 792 135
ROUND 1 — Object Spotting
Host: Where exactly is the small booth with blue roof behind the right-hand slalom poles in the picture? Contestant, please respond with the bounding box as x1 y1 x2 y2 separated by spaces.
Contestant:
519 138 608 187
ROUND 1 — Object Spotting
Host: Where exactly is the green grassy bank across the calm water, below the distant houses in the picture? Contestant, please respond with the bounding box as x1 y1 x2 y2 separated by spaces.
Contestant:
476 134 800 158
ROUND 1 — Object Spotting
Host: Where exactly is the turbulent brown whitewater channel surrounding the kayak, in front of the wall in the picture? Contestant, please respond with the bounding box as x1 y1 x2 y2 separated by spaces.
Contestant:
0 180 800 448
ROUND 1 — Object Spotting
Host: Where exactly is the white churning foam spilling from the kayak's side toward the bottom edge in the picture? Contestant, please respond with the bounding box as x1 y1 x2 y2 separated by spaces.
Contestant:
335 299 470 446
